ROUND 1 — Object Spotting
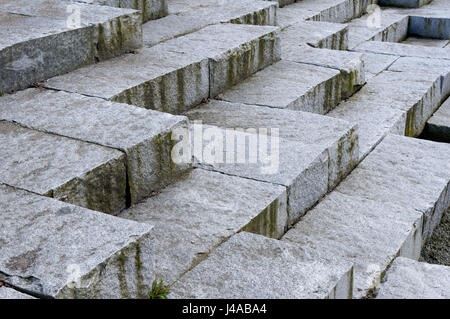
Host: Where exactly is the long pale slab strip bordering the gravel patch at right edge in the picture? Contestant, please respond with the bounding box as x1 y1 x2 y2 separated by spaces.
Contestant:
283 135 450 297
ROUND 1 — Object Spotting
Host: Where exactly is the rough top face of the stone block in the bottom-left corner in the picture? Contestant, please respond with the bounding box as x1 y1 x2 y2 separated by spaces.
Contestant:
0 185 152 297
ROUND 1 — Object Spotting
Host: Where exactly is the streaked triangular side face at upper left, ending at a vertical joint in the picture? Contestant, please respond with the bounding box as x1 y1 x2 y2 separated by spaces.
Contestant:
111 59 209 114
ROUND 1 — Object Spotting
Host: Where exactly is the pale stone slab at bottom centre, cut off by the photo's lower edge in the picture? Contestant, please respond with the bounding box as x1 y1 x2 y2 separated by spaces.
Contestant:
171 232 353 299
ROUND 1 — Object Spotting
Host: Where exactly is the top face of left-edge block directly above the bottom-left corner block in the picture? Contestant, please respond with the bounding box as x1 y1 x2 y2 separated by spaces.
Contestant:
0 122 125 198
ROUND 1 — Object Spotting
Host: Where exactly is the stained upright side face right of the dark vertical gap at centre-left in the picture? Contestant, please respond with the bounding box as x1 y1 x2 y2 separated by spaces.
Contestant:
126 122 192 204
